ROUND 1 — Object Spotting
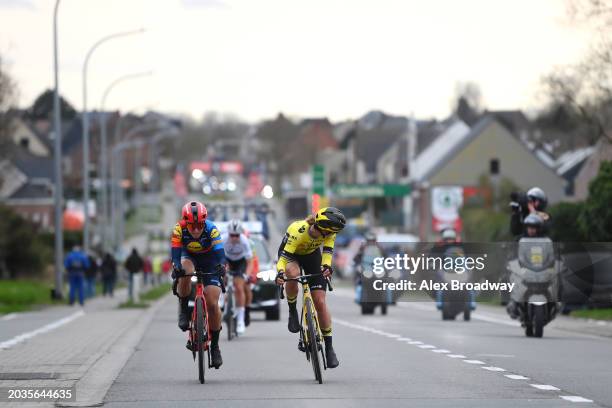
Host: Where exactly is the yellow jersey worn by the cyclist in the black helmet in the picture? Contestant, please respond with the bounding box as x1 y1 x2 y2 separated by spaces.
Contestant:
276 220 336 271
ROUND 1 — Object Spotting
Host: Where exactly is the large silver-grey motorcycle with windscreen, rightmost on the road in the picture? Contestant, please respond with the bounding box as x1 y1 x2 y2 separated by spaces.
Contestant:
507 237 562 337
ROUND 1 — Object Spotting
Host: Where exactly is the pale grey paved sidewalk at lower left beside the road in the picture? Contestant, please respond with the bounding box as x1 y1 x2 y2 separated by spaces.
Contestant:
0 289 167 407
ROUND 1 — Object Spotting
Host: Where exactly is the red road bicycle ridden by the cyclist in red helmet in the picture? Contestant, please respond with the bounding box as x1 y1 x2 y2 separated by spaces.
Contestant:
184 270 225 384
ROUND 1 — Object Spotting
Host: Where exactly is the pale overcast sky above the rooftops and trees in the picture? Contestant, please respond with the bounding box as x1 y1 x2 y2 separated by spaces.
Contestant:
0 0 593 121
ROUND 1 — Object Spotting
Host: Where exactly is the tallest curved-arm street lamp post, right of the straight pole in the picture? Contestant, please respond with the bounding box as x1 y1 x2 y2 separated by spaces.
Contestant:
82 29 144 251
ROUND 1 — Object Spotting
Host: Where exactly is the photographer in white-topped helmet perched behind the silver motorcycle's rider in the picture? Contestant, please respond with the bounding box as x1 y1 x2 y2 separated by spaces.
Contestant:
510 187 550 236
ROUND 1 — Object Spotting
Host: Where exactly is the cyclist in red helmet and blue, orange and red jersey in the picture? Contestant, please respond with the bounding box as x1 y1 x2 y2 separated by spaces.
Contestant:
171 201 225 368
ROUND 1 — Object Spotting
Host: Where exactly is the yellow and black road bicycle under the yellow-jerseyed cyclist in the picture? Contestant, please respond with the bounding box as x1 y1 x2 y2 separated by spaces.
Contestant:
279 271 334 384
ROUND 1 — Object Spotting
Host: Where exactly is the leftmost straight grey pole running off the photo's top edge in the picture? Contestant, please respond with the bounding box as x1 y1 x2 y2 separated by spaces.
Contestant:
53 0 64 299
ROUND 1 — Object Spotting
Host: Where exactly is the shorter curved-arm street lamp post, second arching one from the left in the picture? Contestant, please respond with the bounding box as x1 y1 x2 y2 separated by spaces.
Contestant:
100 71 151 252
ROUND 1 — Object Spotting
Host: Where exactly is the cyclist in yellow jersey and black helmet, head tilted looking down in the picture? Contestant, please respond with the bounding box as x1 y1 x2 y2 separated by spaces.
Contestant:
276 207 346 368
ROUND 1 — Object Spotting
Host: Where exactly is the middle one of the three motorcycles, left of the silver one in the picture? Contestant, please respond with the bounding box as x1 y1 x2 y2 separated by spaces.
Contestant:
436 246 474 321
